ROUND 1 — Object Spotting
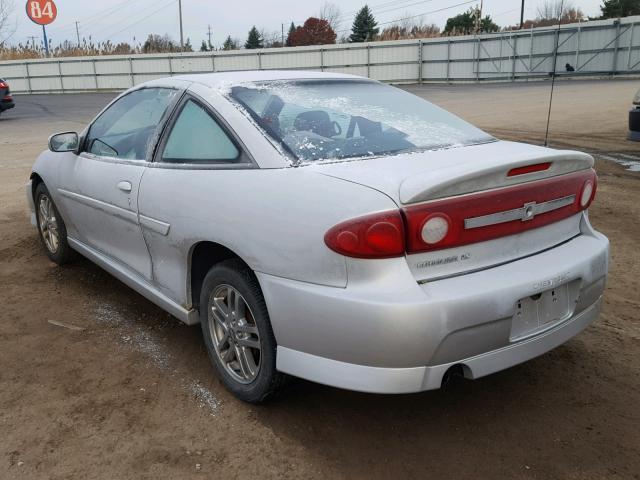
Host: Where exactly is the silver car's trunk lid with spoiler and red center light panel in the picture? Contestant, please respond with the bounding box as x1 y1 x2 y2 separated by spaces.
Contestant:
312 141 595 282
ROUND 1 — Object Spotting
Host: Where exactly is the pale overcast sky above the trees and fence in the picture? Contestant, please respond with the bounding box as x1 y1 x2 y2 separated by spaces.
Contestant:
9 0 602 50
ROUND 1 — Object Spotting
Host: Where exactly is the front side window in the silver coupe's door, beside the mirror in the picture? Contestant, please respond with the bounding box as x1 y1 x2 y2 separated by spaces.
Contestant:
85 88 179 160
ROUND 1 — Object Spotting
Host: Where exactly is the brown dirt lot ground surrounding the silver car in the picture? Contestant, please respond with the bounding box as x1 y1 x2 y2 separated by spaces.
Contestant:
0 81 640 480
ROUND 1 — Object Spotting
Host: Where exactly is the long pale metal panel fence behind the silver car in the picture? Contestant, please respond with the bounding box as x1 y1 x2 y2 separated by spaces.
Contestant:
0 16 640 93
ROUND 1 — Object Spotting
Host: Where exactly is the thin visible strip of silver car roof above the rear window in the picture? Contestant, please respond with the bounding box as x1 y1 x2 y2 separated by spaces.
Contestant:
171 70 365 88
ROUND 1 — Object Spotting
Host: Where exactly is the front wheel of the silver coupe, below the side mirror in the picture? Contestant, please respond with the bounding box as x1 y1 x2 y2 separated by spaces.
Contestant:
33 183 75 265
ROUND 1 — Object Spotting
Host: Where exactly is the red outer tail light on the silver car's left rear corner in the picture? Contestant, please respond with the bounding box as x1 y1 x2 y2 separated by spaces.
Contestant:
324 210 405 258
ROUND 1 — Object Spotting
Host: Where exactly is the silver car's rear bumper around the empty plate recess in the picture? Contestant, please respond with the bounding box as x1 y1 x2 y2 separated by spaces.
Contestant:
257 232 609 393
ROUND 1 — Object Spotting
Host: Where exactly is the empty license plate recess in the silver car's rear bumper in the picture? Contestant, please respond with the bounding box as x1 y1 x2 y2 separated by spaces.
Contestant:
510 283 575 342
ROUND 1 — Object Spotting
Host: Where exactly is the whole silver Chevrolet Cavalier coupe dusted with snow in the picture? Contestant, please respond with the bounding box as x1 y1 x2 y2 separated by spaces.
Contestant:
27 71 608 402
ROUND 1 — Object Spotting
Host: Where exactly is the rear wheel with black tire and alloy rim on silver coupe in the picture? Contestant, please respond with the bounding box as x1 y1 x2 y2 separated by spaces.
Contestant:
200 259 287 403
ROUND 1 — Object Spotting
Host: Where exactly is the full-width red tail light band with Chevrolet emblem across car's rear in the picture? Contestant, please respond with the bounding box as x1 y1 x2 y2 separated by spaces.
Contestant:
324 170 597 258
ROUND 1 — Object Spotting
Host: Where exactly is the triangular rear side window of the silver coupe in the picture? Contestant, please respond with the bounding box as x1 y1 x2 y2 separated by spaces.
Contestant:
162 100 240 163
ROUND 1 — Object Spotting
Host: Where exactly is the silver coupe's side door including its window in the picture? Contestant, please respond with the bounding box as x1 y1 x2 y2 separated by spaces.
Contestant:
58 88 180 280
